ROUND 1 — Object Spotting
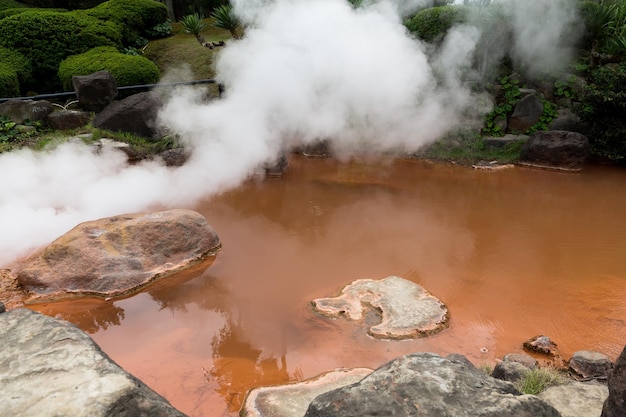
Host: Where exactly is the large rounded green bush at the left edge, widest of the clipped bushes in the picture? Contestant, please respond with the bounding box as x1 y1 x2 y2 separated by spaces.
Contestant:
0 10 121 91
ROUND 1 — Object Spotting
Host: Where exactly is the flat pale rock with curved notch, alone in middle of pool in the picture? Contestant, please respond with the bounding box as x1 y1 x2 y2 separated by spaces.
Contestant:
313 276 449 339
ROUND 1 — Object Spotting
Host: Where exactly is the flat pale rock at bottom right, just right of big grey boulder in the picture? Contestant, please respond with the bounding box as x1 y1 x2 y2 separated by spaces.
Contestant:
539 381 609 417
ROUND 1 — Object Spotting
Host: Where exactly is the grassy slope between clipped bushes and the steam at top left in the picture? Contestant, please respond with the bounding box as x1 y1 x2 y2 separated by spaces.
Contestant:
143 18 231 81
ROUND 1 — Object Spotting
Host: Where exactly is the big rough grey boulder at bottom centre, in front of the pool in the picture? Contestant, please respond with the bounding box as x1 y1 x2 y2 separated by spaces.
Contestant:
305 353 560 417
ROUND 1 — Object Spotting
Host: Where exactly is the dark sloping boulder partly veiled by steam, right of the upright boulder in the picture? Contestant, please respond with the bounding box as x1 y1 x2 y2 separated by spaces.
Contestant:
92 92 163 140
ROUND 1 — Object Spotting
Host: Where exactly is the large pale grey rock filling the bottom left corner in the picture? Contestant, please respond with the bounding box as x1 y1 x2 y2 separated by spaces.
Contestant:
0 309 184 417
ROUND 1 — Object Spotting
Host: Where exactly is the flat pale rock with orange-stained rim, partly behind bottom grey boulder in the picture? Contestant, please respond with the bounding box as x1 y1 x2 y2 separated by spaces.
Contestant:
240 368 372 417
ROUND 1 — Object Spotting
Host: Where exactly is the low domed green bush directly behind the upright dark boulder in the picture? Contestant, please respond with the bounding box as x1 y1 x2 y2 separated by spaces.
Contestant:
58 46 159 90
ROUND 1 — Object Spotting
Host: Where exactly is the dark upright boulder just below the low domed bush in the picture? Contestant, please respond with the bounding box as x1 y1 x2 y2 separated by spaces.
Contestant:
72 71 117 113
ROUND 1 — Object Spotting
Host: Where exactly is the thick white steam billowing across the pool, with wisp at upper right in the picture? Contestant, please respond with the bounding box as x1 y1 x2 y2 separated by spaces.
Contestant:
0 0 574 265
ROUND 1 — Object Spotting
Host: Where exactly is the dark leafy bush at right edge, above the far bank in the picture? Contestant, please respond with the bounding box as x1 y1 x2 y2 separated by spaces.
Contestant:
581 63 626 162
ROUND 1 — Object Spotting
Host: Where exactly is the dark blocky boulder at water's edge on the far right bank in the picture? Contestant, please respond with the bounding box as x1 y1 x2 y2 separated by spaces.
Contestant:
520 130 589 170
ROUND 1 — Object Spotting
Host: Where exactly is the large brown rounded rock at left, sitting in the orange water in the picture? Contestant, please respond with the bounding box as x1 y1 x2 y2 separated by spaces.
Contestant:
17 209 220 298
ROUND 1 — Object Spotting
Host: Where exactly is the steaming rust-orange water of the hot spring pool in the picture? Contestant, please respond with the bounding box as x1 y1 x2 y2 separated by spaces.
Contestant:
33 156 626 417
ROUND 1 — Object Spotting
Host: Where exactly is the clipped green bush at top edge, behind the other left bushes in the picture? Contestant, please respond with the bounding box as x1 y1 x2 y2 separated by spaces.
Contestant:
77 0 167 46
